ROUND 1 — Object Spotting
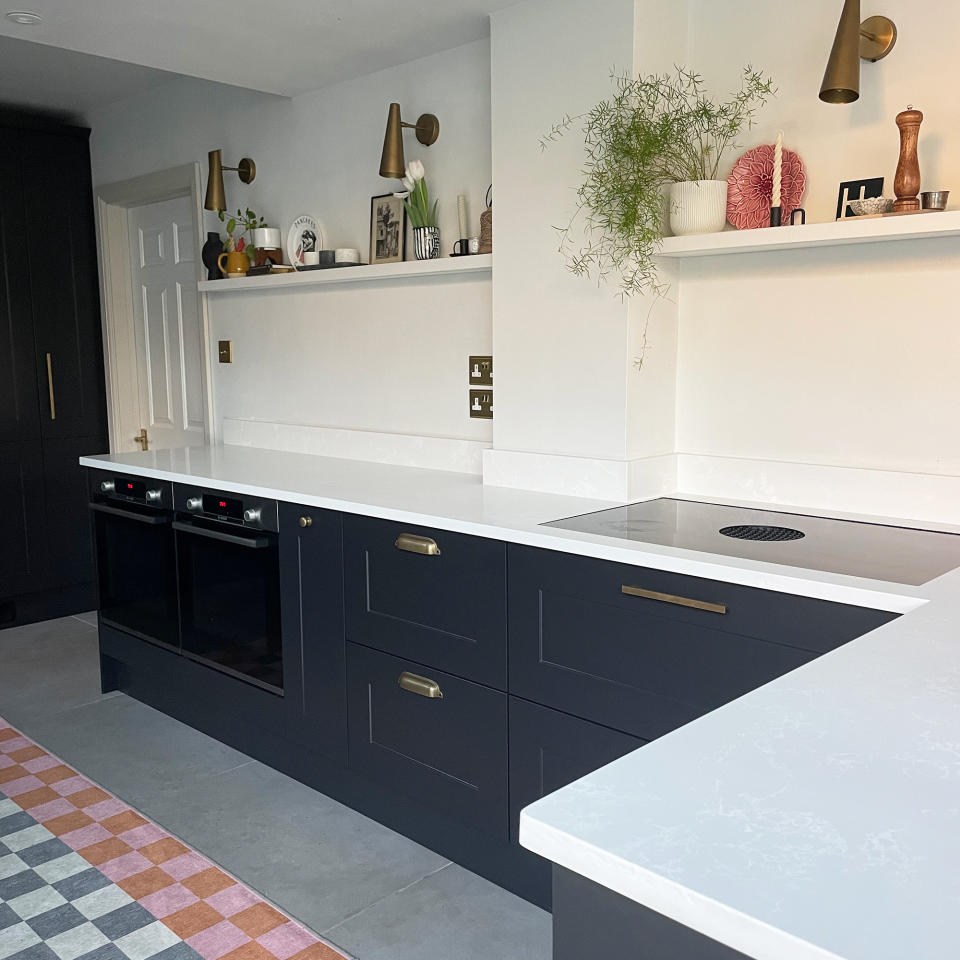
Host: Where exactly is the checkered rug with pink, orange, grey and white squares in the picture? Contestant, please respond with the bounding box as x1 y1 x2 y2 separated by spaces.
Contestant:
0 718 344 960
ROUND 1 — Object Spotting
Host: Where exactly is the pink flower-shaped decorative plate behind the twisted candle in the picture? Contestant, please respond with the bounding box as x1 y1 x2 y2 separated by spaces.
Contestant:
727 143 807 230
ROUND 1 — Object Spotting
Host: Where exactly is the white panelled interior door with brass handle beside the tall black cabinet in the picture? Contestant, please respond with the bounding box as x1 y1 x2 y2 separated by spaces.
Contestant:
124 197 206 449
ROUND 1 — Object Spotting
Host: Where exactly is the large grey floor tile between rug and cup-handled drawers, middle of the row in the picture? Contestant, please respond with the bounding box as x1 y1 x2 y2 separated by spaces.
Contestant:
144 762 448 930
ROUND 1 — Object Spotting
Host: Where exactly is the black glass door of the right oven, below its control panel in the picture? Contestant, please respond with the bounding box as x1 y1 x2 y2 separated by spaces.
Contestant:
174 519 283 693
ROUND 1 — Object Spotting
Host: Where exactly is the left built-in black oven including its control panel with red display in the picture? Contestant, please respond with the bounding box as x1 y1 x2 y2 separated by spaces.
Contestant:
90 471 180 649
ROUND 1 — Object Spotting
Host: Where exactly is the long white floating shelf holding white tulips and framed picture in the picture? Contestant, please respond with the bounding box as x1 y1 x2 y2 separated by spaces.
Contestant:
197 253 493 293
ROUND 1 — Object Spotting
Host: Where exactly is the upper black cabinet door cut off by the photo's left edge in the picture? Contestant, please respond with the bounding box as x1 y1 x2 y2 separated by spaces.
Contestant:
0 127 40 446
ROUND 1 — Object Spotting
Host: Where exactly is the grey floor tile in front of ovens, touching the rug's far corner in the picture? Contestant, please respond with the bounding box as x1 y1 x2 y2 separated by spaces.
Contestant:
15 695 249 816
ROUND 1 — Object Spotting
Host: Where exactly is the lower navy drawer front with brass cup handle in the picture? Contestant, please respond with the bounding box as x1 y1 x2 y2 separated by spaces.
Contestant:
347 643 507 838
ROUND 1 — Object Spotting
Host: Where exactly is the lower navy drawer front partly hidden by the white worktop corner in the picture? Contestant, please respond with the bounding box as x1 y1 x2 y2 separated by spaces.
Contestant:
510 697 646 843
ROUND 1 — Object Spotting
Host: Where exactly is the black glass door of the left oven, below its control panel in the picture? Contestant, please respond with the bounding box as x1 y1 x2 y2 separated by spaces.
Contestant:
90 502 180 649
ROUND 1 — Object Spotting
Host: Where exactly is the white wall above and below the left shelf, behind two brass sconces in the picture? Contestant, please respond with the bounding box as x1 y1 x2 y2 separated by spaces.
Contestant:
88 40 491 466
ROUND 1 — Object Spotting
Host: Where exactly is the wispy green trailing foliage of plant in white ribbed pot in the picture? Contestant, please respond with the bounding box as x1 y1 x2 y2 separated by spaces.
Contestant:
540 66 775 296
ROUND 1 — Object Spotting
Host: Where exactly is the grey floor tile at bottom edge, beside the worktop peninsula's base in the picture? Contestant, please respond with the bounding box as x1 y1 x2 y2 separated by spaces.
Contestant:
323 864 552 960
